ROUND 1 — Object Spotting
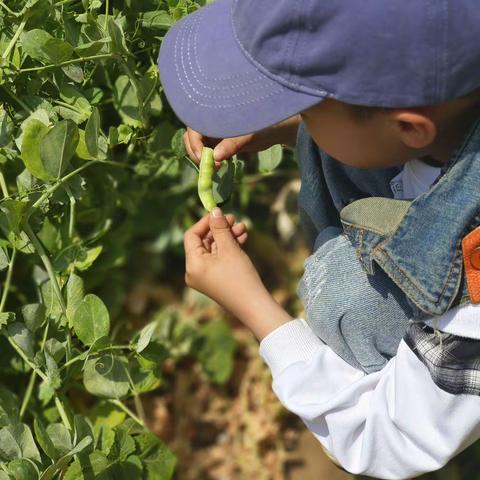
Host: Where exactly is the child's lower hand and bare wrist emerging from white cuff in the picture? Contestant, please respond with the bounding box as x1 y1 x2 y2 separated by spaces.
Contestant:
184 207 292 340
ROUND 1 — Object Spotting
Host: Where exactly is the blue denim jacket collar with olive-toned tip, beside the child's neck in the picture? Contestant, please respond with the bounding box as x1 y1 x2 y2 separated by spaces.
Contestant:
340 117 480 316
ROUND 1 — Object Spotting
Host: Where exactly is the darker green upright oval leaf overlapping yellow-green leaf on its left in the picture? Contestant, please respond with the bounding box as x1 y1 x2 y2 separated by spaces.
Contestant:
40 120 79 178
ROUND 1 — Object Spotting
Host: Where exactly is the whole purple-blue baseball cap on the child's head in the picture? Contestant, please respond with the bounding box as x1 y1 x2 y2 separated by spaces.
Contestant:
158 0 480 138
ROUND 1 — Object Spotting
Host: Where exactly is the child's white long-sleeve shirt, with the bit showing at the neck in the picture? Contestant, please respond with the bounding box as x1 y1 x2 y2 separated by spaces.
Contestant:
259 160 480 479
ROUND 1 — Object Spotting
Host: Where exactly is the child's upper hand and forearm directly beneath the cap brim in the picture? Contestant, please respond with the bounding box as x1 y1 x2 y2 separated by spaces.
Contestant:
183 115 301 170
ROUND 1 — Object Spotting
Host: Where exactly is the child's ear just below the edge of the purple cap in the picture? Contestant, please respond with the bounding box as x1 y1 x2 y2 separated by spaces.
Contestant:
390 109 437 149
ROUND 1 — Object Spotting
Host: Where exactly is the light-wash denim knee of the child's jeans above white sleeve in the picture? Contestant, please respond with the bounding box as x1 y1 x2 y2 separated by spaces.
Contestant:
297 227 412 373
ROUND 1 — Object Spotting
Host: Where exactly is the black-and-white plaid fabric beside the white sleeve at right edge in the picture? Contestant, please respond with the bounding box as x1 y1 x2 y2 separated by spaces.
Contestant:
404 323 480 396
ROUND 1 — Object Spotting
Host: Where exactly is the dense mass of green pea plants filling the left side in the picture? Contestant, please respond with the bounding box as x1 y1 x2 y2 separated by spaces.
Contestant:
0 0 248 480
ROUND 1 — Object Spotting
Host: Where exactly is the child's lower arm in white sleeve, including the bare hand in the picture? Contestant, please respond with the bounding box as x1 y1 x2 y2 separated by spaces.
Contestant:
185 211 480 479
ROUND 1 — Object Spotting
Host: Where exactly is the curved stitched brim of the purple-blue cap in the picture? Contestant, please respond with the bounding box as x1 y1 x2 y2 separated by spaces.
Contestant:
158 0 323 138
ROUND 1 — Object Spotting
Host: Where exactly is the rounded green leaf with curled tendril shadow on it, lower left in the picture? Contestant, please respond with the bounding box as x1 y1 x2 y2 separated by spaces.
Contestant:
83 353 130 399
